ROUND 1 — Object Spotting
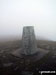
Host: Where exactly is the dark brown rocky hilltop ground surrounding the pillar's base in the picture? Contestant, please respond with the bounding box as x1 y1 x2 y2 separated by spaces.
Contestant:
0 40 56 75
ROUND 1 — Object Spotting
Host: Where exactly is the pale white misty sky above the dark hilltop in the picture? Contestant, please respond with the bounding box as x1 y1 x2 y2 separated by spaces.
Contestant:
0 0 56 41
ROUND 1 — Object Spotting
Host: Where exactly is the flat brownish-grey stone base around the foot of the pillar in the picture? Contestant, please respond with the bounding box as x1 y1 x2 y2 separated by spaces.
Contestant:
11 48 49 62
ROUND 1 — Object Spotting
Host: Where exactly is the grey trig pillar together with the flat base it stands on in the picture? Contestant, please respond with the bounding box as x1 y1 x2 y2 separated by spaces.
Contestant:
12 26 48 61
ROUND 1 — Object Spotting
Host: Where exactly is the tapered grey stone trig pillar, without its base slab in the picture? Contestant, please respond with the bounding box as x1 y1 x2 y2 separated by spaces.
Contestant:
22 26 37 55
